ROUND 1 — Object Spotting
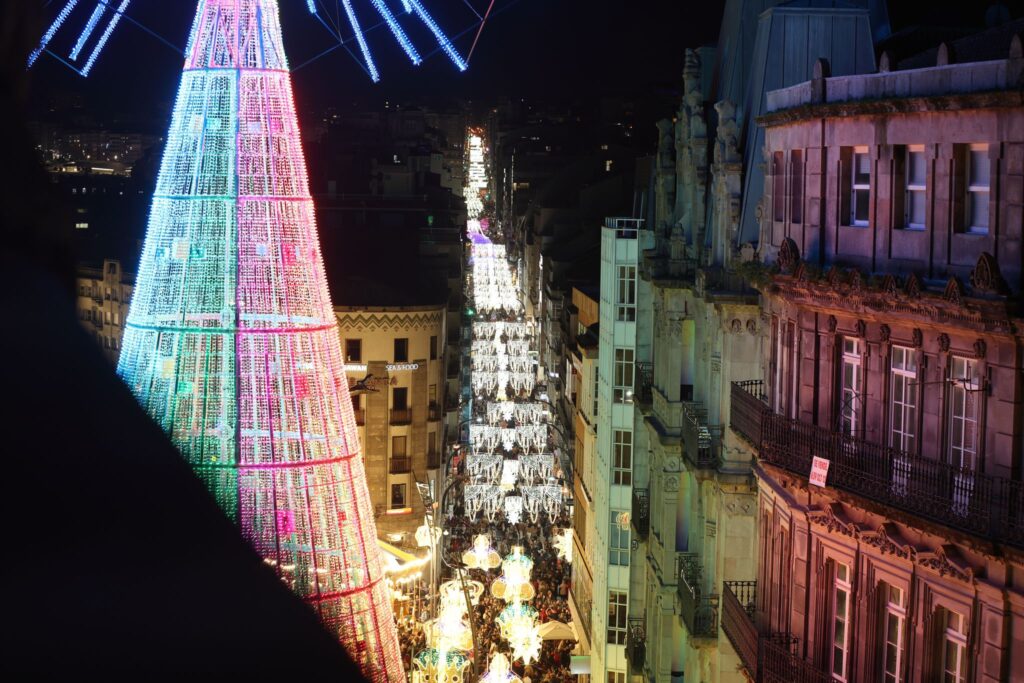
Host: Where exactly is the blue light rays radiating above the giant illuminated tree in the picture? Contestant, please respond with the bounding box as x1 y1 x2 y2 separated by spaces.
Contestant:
28 0 509 83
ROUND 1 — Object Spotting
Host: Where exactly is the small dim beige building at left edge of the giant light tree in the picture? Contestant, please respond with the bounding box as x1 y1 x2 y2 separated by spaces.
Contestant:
76 259 135 366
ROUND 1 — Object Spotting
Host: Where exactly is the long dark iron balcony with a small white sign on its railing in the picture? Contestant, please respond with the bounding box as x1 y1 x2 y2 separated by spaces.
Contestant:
757 405 1024 548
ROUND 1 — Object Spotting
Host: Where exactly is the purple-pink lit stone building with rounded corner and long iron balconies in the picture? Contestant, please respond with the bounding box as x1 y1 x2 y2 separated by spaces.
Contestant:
723 42 1024 683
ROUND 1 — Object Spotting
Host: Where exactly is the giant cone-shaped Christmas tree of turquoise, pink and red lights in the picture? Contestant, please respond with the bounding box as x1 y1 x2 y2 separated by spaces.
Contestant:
118 0 404 681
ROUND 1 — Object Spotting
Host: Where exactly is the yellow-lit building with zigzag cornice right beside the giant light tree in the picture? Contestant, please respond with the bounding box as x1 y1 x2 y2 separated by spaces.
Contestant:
335 304 445 547
